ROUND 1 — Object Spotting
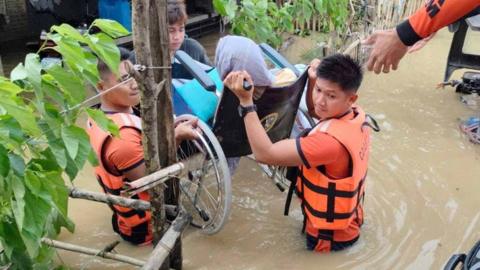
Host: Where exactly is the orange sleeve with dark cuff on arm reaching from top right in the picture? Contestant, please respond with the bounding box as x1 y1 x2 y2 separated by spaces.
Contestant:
397 0 480 46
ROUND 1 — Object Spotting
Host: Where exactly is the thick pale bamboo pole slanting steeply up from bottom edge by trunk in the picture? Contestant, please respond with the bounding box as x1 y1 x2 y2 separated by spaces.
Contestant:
142 210 192 270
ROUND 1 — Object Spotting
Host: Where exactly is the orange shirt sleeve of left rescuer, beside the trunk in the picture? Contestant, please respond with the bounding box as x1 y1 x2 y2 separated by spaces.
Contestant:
104 128 144 173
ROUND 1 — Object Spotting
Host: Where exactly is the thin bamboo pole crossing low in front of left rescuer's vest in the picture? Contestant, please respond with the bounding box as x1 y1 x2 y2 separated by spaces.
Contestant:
69 187 177 216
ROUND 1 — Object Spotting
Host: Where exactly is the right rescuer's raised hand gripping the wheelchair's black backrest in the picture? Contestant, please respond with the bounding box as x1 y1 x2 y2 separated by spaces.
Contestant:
223 70 254 106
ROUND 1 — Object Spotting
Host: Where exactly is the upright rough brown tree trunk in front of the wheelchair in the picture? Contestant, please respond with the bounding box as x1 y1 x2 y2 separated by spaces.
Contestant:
132 0 182 269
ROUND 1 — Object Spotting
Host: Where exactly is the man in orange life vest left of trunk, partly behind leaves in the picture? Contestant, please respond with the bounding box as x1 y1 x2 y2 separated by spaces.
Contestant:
87 48 196 244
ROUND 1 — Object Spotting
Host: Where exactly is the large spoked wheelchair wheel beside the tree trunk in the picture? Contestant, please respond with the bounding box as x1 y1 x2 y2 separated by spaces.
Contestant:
175 115 232 234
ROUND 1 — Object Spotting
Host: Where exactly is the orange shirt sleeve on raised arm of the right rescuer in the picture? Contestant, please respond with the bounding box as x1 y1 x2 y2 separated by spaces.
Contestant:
297 132 348 168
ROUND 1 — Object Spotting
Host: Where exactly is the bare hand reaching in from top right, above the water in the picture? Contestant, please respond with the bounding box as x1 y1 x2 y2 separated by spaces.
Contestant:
362 29 408 74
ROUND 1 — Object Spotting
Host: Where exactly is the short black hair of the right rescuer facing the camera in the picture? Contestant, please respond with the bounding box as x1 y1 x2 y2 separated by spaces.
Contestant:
317 54 363 92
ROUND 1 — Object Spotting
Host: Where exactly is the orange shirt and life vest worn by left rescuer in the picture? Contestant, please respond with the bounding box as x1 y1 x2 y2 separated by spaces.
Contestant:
87 113 152 244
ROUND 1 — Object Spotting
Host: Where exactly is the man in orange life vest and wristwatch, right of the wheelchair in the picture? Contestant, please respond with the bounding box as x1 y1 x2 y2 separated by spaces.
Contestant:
224 54 376 252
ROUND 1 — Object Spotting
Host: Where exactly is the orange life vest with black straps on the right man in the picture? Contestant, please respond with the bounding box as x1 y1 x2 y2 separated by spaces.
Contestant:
297 107 370 234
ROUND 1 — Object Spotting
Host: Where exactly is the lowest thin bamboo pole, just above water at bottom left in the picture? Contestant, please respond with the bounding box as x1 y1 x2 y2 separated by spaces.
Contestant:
42 238 145 266
